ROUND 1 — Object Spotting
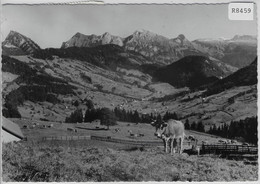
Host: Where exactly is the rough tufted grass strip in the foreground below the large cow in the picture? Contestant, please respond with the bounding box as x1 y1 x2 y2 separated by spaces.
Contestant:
2 143 258 182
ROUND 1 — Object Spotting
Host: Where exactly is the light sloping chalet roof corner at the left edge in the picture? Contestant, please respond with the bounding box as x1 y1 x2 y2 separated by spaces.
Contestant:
2 116 24 139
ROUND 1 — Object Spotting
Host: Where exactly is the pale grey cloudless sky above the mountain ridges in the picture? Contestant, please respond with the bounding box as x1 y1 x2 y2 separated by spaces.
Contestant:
1 4 257 48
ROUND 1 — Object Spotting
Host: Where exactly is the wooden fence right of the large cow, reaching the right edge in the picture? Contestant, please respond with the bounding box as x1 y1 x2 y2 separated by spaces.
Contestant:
200 144 258 155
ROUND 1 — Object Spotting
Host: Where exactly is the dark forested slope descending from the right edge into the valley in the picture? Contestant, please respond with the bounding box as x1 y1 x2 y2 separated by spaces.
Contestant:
205 58 257 95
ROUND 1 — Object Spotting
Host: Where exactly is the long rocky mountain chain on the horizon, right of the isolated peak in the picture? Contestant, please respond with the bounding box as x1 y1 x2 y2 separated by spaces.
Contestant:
61 30 257 68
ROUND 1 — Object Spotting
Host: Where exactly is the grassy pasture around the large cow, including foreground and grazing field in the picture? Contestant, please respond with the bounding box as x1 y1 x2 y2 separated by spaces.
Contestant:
2 119 258 182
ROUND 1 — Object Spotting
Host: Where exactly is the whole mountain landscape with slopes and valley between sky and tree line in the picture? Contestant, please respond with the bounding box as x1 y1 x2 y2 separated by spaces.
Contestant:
2 30 257 122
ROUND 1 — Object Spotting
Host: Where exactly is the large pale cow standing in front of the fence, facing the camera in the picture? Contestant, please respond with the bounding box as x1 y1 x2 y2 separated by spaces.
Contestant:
151 119 185 154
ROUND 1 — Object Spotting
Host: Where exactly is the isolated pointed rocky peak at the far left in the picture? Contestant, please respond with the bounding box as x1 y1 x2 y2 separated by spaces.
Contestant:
2 31 41 55
